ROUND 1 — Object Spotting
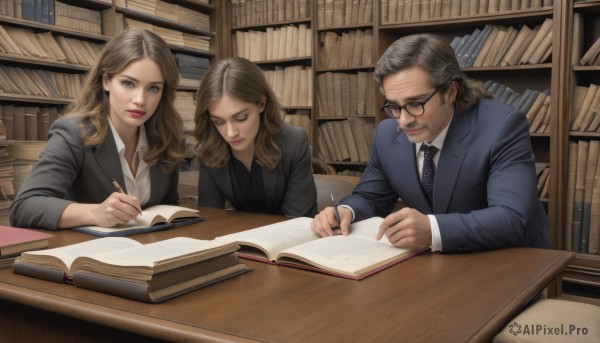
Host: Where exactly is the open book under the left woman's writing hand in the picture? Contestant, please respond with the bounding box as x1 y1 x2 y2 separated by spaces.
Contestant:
73 205 204 237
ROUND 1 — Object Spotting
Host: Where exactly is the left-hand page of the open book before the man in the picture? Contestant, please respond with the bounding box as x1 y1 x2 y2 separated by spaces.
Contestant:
216 217 318 261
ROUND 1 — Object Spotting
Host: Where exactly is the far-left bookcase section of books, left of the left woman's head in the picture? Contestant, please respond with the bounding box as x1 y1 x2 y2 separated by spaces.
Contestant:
0 0 112 225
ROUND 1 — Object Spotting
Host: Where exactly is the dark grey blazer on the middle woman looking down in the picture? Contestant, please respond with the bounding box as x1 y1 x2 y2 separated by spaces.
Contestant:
198 124 317 217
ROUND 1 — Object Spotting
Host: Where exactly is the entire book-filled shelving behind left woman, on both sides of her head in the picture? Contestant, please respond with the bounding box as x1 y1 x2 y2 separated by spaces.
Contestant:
0 0 217 224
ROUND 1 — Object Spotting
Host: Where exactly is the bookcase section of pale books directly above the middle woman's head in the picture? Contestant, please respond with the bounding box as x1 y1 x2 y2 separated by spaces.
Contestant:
227 0 314 162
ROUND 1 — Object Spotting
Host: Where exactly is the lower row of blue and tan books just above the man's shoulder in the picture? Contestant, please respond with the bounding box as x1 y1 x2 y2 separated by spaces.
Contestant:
483 80 551 133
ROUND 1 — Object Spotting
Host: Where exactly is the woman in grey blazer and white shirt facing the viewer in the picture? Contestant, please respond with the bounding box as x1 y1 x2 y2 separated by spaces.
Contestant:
10 30 183 229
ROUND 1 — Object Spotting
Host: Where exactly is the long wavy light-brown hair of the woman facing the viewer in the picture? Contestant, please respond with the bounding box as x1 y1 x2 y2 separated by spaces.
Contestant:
69 29 184 172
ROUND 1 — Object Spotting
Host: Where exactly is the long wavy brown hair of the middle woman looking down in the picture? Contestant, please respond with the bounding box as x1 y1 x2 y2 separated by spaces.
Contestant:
194 57 283 169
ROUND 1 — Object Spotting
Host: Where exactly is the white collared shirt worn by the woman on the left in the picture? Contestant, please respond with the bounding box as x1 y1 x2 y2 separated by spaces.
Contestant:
108 118 151 207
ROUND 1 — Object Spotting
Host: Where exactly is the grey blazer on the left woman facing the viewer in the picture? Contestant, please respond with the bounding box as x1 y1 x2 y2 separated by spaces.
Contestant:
10 116 179 230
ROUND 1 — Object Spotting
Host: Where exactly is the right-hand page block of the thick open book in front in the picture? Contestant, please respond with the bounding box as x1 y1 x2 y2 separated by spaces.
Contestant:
71 237 237 278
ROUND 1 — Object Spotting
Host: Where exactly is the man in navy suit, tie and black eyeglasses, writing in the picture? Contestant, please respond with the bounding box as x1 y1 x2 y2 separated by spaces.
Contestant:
311 34 550 253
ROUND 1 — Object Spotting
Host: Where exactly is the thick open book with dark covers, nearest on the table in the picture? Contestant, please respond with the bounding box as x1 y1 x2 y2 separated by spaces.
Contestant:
13 237 250 303
